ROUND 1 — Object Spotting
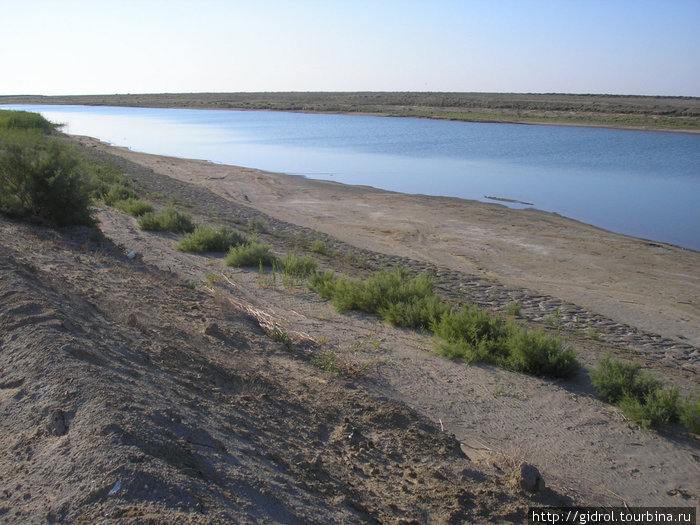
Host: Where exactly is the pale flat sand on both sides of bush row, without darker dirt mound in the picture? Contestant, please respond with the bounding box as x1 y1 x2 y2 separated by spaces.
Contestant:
74 138 700 505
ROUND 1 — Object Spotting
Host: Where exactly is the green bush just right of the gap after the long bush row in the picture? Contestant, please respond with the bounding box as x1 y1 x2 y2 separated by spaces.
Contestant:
591 356 662 404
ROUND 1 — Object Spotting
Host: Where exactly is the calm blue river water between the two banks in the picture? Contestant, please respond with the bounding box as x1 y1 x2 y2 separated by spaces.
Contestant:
7 106 700 250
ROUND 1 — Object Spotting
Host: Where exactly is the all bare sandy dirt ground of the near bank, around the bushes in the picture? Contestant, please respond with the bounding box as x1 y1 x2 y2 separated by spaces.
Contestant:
0 138 700 523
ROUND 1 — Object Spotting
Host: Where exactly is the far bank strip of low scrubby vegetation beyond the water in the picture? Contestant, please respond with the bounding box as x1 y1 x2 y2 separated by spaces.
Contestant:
0 92 700 133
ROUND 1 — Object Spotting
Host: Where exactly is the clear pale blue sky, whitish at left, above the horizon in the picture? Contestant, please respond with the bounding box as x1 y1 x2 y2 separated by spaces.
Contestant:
0 0 700 97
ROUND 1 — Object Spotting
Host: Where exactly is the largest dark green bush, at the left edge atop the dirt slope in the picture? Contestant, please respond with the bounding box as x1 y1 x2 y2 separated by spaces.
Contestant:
0 128 95 226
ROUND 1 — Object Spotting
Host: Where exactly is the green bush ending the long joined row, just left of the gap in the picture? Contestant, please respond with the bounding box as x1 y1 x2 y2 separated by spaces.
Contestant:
505 324 581 379
